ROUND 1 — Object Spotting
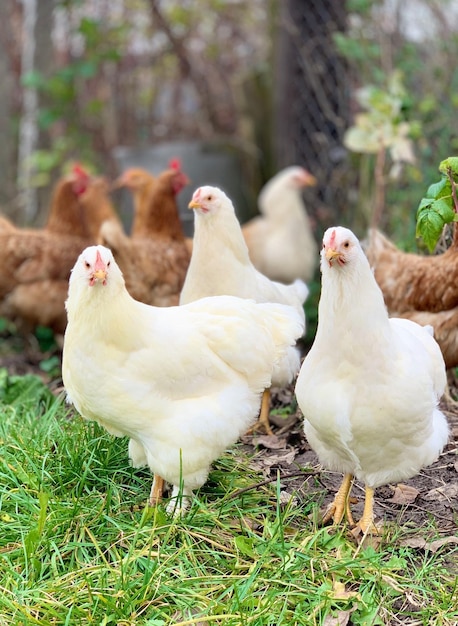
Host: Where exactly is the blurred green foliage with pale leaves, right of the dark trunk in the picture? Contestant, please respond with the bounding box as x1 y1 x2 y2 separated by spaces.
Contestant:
335 0 458 250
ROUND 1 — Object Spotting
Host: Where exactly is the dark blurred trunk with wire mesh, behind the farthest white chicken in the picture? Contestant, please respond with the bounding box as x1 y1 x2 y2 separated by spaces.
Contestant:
275 0 350 226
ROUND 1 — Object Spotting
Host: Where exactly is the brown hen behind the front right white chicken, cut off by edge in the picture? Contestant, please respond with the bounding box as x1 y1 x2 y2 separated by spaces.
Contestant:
366 229 458 368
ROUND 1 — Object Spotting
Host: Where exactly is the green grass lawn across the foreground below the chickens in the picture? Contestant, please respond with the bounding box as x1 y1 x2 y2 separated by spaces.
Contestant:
0 375 458 626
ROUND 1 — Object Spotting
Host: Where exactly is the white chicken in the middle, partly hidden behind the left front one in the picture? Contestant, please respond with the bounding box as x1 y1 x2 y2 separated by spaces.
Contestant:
180 186 308 434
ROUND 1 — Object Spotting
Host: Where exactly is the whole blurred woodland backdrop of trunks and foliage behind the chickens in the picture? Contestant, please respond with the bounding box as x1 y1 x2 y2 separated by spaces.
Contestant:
0 0 458 250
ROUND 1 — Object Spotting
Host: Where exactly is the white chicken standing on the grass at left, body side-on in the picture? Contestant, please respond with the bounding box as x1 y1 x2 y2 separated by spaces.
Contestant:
62 246 302 512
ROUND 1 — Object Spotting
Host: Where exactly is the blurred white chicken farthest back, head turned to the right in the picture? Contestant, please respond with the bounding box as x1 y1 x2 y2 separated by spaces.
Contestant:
242 165 318 283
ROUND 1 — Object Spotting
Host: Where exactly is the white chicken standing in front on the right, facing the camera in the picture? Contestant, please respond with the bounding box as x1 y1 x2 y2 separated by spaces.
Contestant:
295 227 449 536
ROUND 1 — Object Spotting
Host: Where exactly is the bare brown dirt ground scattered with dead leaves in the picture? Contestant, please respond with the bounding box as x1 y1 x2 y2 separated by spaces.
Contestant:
0 333 458 547
